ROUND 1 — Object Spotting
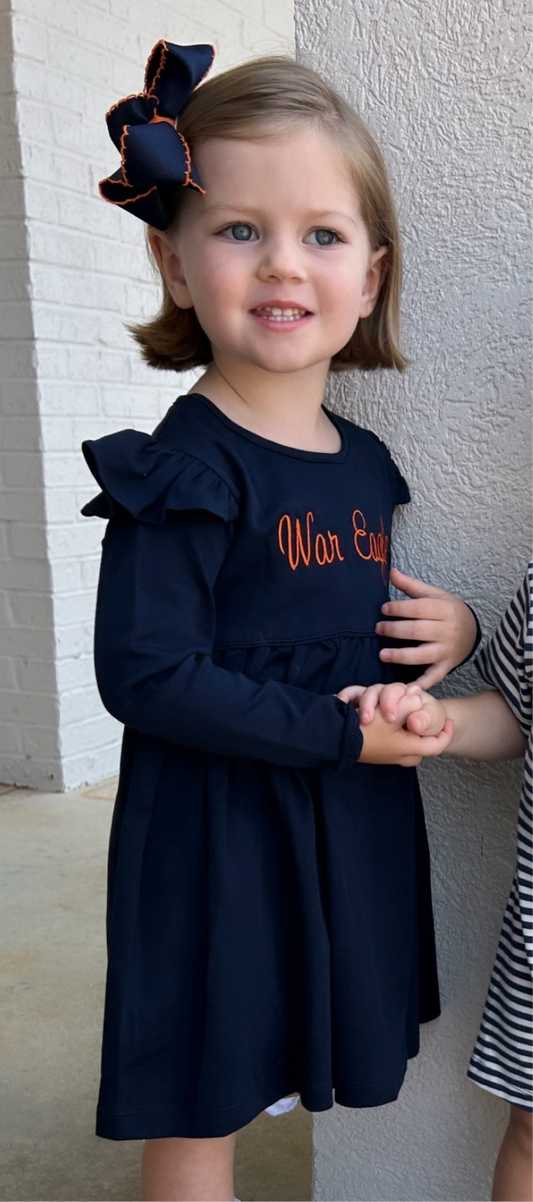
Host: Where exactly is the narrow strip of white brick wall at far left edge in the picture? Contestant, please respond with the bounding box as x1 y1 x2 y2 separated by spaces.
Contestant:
0 0 61 787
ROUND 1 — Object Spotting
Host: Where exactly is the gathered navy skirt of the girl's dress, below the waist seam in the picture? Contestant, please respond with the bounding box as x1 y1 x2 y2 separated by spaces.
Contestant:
97 677 439 1139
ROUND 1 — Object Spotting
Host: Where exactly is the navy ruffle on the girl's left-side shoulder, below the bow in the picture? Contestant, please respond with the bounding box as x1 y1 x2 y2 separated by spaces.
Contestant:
82 430 238 525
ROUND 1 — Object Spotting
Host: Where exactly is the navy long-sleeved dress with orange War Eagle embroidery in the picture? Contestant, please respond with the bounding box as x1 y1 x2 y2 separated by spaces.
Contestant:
84 394 439 1139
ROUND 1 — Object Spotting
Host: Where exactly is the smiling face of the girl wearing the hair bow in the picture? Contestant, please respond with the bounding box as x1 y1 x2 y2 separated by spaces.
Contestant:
152 127 385 373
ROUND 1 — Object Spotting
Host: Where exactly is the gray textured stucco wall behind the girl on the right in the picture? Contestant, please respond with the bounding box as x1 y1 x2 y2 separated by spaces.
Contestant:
296 0 533 1202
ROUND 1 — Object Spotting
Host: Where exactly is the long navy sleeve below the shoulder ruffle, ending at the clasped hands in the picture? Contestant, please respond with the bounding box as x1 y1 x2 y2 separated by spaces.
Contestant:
85 430 362 768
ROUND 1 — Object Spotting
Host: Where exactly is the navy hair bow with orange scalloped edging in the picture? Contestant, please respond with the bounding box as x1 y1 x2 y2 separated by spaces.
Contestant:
99 41 215 230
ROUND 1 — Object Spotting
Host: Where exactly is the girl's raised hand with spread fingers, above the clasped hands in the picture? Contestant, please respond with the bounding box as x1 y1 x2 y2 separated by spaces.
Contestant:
375 567 476 689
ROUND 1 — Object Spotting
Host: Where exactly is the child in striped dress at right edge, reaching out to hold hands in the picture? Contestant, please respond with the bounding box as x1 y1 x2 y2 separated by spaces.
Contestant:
349 560 533 1202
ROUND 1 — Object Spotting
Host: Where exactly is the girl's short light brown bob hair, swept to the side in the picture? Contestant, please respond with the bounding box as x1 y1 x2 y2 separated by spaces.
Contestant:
130 56 407 371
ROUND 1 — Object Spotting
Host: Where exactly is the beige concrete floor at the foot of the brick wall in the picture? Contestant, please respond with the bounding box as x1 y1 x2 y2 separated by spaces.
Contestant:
0 781 312 1202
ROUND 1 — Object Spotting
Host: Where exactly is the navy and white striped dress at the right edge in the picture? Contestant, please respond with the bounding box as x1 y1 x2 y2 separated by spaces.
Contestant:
468 560 533 1112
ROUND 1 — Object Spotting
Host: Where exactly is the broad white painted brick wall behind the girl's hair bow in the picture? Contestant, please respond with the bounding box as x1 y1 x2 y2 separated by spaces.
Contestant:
0 0 294 787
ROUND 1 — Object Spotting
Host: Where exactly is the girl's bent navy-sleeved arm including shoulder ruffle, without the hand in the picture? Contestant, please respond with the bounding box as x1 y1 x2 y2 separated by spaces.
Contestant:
83 429 377 769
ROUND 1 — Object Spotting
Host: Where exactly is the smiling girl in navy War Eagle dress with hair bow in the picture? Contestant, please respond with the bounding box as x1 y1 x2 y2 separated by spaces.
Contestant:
84 42 475 1202
